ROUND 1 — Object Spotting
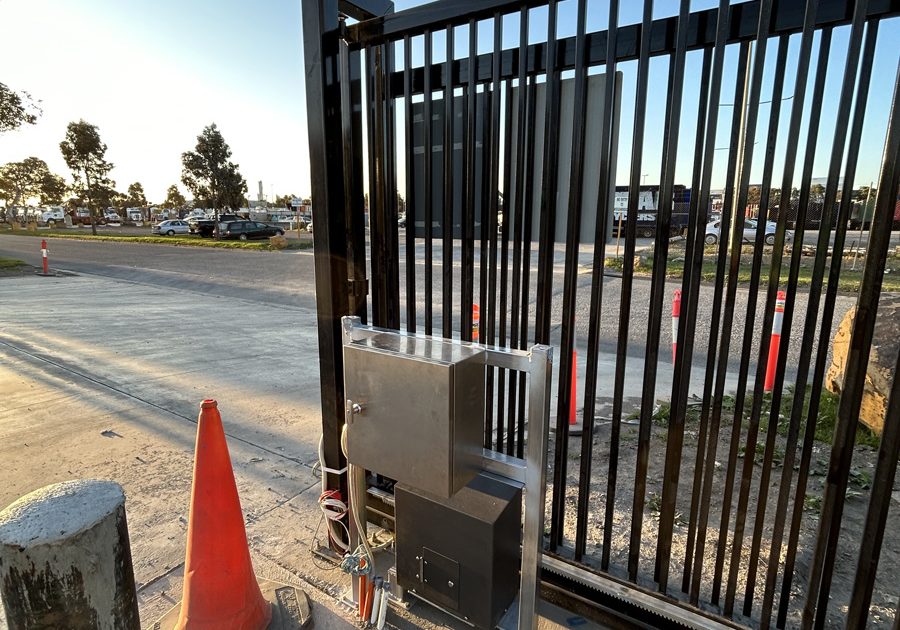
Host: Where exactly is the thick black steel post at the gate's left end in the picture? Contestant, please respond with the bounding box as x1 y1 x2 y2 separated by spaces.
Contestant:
302 0 353 512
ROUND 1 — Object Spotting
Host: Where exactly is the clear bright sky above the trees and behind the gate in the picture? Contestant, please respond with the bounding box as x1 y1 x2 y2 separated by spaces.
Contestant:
0 0 900 203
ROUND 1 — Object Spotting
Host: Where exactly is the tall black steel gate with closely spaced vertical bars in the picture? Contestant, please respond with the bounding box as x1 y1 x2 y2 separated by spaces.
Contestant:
303 0 900 628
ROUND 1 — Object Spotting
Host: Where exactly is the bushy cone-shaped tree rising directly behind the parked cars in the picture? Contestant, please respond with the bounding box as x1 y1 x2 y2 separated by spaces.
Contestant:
181 123 247 238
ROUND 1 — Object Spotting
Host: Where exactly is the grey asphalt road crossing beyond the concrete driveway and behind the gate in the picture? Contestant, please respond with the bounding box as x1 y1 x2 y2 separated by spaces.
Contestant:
0 233 855 404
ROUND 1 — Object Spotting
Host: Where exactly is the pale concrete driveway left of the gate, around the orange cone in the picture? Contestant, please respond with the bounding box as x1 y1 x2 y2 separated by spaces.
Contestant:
0 274 591 629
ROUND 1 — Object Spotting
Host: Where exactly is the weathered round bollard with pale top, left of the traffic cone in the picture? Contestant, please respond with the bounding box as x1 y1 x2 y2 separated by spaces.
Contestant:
0 480 140 630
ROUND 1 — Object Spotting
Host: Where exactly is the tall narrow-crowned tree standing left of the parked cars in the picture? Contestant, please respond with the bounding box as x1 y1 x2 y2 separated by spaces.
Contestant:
59 120 115 235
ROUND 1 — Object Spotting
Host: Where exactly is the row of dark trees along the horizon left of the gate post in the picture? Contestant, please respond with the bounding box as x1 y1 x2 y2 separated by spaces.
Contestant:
0 83 247 233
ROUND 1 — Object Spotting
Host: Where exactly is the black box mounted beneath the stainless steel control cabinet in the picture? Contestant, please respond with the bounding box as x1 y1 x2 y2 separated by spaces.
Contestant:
394 474 522 629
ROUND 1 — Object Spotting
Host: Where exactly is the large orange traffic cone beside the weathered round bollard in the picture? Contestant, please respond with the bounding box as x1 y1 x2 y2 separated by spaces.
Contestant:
175 400 272 630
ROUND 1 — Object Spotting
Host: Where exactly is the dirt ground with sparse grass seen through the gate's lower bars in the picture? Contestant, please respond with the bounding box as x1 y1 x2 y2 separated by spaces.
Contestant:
547 392 900 628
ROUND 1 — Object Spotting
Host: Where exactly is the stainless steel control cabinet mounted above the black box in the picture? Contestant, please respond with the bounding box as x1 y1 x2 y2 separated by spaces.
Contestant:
344 333 486 498
